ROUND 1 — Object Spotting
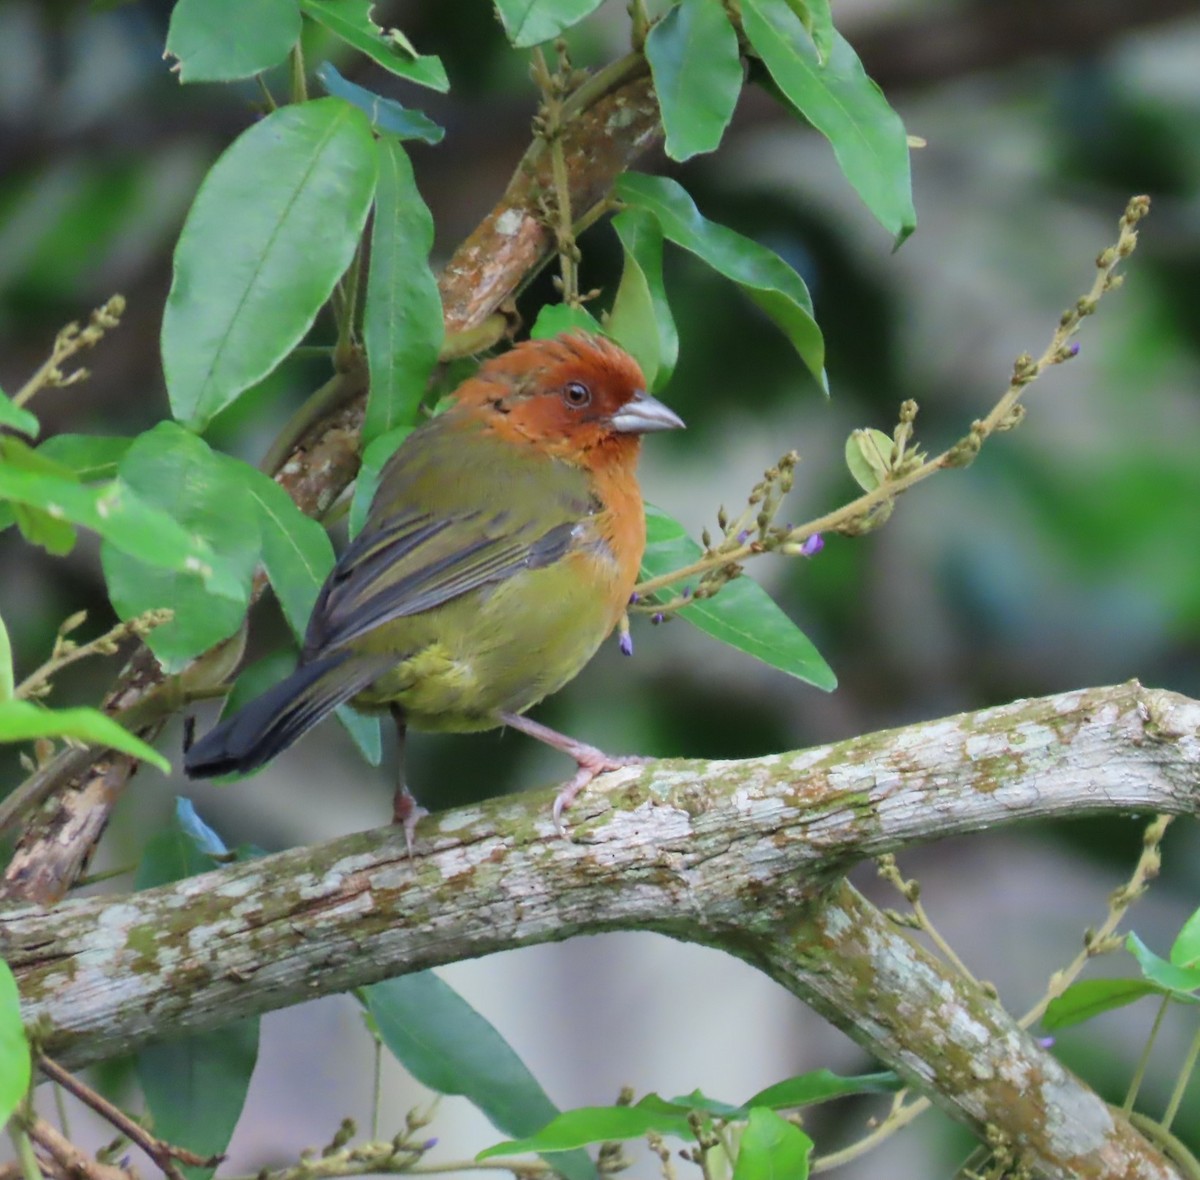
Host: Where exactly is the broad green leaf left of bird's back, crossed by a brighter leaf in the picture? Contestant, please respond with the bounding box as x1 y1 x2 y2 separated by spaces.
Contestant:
101 421 260 672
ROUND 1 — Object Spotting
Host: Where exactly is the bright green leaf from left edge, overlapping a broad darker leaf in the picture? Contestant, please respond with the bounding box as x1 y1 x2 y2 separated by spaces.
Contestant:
0 436 241 598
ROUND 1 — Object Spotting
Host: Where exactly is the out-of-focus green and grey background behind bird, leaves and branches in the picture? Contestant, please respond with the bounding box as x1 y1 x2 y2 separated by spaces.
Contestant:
0 0 1200 1178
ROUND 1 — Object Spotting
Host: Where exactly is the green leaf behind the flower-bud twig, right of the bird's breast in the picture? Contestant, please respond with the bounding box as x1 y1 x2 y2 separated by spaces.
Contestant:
642 504 838 693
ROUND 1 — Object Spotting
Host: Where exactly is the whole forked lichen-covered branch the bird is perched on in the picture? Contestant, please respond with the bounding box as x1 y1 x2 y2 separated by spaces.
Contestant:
0 682 1200 1176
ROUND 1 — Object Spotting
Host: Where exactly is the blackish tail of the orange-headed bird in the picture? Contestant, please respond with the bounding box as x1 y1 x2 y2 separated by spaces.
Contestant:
184 652 392 779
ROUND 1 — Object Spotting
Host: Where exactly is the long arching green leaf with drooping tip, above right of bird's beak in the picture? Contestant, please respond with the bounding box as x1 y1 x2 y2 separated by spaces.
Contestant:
614 172 828 391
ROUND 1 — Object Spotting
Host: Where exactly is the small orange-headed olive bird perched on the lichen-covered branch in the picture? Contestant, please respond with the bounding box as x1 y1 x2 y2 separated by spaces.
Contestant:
184 331 684 855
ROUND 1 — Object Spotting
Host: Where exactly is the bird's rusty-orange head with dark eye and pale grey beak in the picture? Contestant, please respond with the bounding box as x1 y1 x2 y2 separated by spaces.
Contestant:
457 331 683 466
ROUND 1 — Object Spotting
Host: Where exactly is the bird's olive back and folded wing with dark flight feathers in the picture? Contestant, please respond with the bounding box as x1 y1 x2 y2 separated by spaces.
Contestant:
305 415 594 659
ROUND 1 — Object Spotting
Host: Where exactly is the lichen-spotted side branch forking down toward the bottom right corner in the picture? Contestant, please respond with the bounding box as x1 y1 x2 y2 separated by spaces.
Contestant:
739 881 1178 1180
